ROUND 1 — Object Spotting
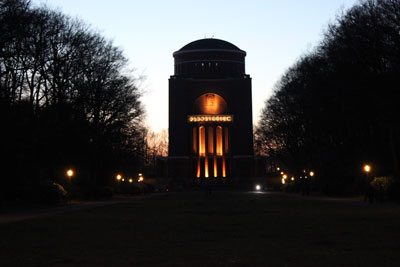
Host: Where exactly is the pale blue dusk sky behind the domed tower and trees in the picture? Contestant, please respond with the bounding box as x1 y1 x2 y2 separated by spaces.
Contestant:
32 0 358 132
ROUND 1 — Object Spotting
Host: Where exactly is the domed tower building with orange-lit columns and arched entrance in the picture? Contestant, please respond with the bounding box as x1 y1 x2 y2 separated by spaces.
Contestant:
168 39 253 181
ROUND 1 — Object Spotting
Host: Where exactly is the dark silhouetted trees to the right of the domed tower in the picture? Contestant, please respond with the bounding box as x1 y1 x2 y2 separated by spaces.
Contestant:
256 0 400 197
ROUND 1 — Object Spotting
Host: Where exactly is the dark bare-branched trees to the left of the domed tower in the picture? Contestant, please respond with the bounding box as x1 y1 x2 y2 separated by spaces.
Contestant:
0 0 144 201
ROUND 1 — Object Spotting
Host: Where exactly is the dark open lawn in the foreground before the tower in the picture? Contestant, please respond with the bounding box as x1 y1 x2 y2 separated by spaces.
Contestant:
0 192 400 266
